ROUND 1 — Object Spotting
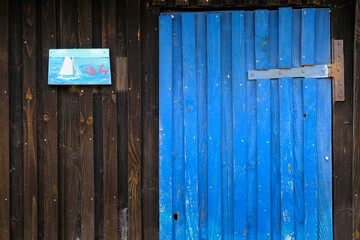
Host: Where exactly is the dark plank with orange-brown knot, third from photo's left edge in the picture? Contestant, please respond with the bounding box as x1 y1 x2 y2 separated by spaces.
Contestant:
22 0 38 239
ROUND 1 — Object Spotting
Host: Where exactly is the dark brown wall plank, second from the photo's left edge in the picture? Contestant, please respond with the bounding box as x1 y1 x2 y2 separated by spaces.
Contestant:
9 0 24 236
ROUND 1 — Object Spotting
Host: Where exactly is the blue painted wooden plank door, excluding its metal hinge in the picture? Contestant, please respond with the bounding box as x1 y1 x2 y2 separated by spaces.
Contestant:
159 8 333 240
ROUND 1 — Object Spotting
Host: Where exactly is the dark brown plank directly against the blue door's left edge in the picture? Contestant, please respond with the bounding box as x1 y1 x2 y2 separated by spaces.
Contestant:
140 1 158 240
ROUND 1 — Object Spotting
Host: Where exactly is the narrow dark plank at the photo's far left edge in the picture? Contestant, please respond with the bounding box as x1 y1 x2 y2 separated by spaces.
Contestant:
0 0 10 240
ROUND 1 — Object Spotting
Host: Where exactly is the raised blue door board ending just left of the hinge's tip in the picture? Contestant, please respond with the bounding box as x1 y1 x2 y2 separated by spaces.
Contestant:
231 11 247 240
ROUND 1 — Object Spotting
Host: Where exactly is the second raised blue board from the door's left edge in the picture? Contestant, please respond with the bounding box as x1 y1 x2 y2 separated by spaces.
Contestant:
182 13 199 239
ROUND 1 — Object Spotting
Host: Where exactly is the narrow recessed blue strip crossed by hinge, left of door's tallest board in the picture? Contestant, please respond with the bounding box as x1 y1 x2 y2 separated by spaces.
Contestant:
269 11 281 240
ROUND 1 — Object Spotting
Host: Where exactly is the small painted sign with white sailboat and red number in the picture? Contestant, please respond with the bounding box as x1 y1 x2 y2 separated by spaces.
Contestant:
48 48 111 85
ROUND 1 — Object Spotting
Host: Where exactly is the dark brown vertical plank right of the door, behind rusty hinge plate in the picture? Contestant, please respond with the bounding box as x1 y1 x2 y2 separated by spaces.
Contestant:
330 0 356 240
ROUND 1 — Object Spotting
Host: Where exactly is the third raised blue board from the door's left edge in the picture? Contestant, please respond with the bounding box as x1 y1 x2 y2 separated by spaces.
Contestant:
207 13 222 239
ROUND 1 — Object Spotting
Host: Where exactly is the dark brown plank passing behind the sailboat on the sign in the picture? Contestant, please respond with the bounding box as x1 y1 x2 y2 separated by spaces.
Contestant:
58 0 82 239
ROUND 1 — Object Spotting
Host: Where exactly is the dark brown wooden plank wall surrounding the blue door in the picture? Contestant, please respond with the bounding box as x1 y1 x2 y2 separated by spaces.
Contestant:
0 0 360 240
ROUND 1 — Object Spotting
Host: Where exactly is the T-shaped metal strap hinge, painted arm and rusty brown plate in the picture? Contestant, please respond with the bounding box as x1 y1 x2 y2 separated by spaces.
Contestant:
248 40 345 102
